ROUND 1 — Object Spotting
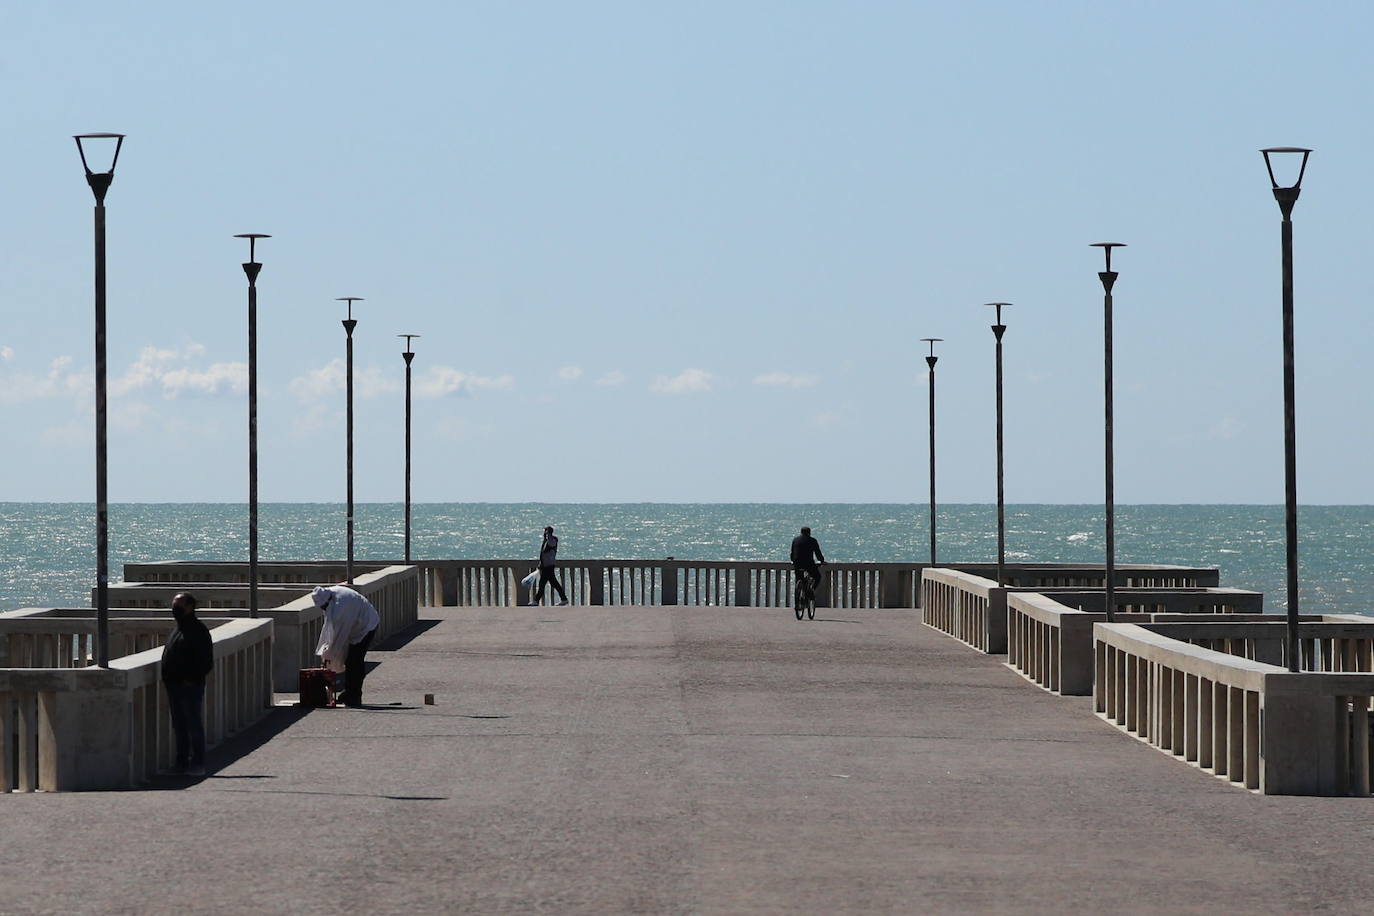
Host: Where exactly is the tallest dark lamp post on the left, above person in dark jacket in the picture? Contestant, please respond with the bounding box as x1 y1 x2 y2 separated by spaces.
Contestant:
74 133 124 667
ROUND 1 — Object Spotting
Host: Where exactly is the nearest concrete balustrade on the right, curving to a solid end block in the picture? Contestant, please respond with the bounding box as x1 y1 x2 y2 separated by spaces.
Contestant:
1092 623 1374 795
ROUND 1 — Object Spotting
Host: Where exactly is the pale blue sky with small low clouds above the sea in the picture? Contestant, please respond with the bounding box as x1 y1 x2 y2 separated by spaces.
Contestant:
0 0 1374 504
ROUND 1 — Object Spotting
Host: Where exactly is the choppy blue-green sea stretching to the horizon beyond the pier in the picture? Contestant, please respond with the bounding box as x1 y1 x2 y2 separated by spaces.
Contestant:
0 503 1374 614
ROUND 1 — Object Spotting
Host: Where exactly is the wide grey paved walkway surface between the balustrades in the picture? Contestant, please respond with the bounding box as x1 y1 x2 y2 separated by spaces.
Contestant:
8 607 1374 916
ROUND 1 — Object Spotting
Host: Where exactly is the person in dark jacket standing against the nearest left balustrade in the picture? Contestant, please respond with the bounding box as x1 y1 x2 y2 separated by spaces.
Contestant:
162 592 214 776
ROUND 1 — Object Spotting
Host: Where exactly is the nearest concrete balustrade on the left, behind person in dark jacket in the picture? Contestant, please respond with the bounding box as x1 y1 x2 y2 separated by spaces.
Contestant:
0 618 272 792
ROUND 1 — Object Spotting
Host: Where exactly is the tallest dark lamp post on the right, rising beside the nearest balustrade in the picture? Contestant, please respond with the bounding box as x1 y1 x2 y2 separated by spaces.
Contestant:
1260 147 1312 672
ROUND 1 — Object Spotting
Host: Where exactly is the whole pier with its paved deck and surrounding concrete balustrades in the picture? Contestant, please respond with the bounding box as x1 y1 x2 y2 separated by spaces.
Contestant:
8 560 1374 913
